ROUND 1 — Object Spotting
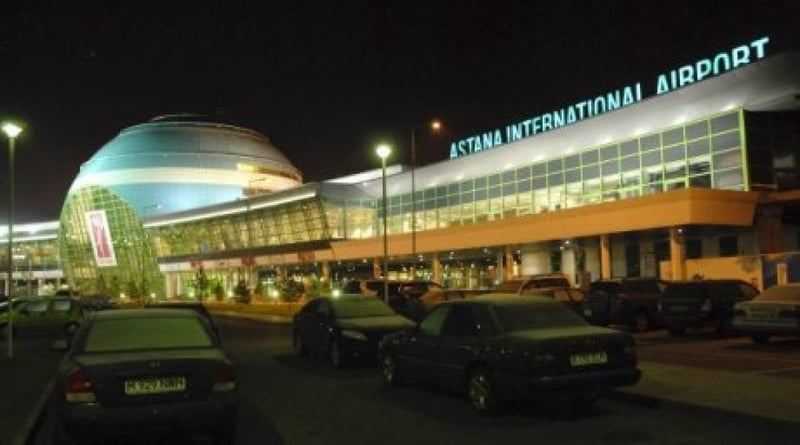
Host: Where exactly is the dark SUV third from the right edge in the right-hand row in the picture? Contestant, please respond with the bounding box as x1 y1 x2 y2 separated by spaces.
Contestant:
583 278 667 332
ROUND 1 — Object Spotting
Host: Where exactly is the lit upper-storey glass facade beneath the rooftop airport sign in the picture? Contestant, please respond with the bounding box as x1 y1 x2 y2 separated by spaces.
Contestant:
333 110 749 239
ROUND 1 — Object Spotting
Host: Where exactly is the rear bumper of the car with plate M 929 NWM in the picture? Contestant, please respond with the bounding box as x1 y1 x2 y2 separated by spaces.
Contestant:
60 394 238 444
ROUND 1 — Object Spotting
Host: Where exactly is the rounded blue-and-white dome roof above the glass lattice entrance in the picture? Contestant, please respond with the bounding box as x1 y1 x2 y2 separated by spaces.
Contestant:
70 115 302 217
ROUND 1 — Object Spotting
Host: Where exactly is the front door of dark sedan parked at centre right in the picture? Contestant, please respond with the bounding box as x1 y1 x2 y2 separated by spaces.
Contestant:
399 305 450 382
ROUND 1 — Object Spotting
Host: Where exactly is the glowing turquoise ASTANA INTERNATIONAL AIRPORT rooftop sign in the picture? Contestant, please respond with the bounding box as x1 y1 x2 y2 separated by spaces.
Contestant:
450 37 769 159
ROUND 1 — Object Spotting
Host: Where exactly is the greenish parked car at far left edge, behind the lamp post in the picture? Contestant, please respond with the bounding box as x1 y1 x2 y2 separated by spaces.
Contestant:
0 297 83 334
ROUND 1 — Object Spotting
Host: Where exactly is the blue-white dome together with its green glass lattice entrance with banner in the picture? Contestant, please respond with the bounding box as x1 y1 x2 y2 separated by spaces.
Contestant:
59 115 302 298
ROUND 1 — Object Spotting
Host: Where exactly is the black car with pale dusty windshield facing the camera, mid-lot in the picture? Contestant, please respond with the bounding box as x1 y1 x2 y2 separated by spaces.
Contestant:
292 294 414 368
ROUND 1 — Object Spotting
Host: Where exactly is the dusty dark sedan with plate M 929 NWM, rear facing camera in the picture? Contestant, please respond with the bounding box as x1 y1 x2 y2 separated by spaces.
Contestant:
50 309 239 444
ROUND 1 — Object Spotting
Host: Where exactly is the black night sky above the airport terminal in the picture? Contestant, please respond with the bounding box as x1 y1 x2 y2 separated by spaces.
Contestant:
0 0 800 224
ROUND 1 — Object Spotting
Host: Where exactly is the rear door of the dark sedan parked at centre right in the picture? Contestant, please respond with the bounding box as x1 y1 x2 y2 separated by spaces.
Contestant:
436 304 480 391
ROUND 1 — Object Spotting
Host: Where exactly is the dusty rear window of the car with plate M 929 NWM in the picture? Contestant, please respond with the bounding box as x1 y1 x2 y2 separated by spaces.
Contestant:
83 317 213 352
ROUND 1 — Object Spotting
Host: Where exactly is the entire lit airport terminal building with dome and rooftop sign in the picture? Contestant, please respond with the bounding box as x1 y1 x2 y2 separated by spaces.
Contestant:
3 38 800 297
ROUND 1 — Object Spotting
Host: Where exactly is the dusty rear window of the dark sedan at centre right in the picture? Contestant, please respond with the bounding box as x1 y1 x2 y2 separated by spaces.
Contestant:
495 303 586 332
